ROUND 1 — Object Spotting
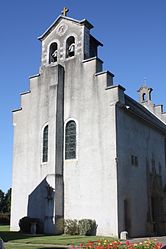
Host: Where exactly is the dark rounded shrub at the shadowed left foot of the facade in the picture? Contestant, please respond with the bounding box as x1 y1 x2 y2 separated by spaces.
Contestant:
19 216 43 233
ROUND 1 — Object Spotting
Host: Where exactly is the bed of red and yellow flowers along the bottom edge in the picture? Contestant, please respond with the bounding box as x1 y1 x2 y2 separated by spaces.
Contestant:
72 240 162 249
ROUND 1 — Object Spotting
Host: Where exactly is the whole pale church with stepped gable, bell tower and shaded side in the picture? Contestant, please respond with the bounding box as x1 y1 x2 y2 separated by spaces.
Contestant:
11 9 166 237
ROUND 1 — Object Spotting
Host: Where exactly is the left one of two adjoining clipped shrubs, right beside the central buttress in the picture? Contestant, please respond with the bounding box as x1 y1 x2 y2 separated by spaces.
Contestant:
64 219 79 235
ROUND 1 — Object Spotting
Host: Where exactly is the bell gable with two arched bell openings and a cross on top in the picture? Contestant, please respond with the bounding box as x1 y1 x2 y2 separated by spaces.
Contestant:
38 8 103 69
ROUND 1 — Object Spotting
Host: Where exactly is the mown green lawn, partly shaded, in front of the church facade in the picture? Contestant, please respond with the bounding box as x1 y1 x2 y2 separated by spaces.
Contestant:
0 226 113 249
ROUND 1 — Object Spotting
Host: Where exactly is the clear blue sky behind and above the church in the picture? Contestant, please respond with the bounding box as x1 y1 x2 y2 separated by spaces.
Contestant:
0 0 166 192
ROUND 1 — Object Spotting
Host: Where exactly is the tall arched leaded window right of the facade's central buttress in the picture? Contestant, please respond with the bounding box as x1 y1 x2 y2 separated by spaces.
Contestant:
65 120 76 159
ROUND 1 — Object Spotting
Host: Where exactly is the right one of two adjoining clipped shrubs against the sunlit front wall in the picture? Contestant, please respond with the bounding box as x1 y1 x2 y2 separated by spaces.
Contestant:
78 219 97 235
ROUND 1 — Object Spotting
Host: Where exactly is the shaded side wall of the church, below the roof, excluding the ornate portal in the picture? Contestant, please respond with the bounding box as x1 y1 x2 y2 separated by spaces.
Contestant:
117 107 166 237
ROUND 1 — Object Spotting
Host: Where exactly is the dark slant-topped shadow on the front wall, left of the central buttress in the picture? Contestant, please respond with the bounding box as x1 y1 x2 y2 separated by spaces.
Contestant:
27 175 55 233
